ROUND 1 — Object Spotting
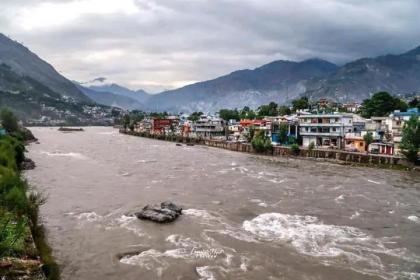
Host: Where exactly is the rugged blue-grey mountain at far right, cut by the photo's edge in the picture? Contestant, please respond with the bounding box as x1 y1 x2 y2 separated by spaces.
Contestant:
305 46 420 102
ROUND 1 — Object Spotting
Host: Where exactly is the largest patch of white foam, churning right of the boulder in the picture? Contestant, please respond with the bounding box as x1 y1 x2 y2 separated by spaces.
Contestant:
242 213 420 279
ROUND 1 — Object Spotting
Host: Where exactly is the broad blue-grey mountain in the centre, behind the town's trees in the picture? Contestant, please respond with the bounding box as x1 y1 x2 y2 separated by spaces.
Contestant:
146 59 338 112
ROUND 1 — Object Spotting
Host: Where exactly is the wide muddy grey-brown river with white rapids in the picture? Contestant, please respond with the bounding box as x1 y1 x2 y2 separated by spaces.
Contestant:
26 127 420 280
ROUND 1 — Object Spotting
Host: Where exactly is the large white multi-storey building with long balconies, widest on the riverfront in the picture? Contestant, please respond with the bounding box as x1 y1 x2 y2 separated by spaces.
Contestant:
299 114 353 149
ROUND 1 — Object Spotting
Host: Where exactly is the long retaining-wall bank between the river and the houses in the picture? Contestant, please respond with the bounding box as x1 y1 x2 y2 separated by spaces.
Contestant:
119 129 412 170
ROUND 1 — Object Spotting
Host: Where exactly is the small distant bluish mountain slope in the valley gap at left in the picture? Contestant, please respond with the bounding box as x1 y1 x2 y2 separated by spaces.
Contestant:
76 84 144 110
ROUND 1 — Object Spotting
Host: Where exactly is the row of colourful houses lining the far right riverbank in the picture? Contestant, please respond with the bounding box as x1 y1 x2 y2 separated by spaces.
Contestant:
134 108 420 155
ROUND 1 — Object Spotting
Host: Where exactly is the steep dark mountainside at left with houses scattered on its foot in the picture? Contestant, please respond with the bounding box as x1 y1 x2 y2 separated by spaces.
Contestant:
0 34 118 125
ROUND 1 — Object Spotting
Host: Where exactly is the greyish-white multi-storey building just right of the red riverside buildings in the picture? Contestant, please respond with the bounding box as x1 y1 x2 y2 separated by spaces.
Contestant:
193 115 225 138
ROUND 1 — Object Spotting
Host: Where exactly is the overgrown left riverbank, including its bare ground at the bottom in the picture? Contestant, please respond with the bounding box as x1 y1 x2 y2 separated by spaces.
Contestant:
0 128 59 280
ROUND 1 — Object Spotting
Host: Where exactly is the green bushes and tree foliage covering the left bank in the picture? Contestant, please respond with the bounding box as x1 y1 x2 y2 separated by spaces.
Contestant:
0 109 58 279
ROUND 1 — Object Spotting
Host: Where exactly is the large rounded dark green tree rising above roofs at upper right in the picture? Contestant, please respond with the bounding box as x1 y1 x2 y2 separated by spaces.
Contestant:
360 91 408 118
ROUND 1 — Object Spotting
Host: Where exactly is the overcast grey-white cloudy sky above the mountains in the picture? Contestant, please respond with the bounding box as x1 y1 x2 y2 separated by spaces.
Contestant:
0 0 420 92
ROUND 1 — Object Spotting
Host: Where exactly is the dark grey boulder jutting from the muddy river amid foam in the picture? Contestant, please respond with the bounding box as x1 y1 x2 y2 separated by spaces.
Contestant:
134 201 182 223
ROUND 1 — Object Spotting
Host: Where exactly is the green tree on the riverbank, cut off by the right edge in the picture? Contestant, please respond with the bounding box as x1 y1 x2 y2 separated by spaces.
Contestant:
400 115 420 165
